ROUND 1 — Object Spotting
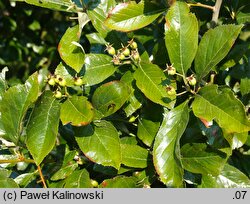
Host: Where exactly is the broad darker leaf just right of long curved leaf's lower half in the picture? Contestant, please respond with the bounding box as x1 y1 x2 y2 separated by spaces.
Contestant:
181 143 226 175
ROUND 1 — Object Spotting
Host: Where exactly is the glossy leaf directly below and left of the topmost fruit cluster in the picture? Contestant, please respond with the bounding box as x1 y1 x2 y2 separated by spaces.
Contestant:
84 54 116 86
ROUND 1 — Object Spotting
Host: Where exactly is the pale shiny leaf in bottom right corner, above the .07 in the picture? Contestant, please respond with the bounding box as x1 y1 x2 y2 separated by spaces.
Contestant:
199 164 250 188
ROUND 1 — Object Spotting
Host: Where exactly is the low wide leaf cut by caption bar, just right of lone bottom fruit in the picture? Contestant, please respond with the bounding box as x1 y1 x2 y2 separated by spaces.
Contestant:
100 176 136 188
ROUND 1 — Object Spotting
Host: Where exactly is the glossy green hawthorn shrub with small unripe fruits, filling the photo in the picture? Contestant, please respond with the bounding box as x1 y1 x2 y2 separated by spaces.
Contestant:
0 0 250 188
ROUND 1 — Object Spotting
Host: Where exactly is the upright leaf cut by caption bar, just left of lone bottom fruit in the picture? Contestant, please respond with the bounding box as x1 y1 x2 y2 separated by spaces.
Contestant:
64 169 92 188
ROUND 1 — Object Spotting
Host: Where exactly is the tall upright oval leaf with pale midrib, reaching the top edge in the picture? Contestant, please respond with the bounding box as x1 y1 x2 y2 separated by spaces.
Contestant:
165 2 198 75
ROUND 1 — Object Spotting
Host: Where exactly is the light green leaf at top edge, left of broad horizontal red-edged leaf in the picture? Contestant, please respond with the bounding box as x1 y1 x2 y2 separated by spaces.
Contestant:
87 0 116 38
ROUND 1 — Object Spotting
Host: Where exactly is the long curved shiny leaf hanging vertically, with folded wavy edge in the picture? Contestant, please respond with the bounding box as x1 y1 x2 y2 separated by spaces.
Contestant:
153 101 189 187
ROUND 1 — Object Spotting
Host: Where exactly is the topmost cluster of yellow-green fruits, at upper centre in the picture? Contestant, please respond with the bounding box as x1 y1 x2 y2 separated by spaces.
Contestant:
105 39 140 65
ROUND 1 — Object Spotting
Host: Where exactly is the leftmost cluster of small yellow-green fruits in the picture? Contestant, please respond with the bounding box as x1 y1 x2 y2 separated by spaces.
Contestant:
47 75 84 99
